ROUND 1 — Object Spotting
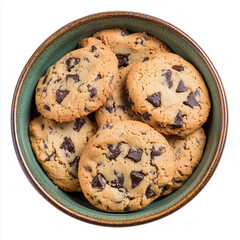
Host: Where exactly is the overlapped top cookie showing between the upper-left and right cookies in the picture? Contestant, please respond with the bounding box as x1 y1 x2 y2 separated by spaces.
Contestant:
93 28 170 125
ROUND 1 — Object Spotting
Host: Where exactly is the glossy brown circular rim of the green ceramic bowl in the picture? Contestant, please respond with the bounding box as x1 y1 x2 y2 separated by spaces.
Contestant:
11 11 228 227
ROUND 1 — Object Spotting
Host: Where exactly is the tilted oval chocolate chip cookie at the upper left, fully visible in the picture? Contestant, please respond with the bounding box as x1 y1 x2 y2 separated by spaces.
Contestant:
35 38 118 122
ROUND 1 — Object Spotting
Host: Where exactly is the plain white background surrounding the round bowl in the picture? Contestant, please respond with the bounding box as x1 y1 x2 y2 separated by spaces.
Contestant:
0 0 240 240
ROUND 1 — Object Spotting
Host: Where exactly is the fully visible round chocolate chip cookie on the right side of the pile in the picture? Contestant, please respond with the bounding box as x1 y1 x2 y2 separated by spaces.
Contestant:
126 53 211 136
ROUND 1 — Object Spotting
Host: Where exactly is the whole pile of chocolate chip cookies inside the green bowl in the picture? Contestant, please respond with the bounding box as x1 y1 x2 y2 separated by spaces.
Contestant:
29 29 211 212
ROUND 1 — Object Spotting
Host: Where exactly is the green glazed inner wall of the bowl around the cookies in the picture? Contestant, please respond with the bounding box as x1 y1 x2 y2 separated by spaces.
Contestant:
16 13 222 221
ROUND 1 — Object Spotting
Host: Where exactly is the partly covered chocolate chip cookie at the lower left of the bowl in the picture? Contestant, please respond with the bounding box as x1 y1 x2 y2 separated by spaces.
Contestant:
29 116 97 192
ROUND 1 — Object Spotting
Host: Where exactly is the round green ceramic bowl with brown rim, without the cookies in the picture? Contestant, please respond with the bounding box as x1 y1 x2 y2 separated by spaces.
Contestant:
11 12 228 226
